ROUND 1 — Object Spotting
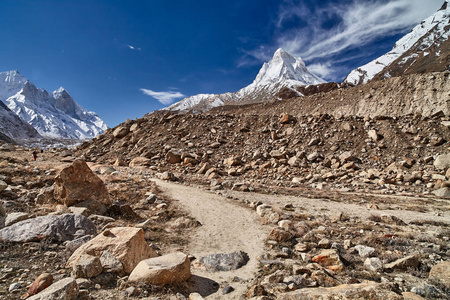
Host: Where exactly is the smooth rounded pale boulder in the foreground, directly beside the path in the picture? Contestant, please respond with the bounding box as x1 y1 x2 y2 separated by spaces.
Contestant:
128 252 191 285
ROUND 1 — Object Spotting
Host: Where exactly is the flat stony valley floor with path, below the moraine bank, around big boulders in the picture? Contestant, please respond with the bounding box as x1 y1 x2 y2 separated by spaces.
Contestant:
0 148 450 299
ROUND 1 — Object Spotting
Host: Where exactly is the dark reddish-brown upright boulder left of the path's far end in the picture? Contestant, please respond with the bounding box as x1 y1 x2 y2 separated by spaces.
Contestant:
53 160 111 206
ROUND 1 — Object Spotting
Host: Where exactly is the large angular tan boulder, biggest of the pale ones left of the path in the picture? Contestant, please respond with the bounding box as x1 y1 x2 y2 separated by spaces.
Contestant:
66 227 157 274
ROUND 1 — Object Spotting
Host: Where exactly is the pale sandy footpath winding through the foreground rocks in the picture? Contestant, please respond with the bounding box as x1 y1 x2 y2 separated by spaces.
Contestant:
154 179 271 299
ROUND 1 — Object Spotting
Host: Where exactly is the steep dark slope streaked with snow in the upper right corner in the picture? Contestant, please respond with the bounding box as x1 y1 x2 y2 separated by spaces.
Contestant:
344 0 450 84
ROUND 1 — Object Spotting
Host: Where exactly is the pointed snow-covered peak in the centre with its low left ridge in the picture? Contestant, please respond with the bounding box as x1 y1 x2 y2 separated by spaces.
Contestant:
166 49 325 111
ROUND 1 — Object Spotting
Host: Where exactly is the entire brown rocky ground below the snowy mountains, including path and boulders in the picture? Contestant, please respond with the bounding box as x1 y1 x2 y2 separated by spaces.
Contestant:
0 73 450 299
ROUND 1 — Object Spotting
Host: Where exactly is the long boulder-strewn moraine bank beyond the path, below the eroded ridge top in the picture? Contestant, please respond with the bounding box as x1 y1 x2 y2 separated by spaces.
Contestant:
76 108 450 197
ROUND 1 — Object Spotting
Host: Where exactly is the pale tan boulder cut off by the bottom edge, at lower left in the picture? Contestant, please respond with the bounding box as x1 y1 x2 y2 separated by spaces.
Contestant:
28 277 78 300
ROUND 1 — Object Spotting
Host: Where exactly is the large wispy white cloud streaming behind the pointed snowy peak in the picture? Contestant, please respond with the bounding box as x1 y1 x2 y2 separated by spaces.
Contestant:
243 0 443 78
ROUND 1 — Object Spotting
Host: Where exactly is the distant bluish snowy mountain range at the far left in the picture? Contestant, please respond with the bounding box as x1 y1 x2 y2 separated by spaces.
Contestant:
0 71 107 139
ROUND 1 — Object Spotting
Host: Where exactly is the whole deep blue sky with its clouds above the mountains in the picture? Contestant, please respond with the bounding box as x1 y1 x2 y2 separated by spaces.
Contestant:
0 0 444 127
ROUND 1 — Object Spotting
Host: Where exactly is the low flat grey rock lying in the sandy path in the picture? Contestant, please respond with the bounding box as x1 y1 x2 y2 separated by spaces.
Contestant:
200 251 249 272
